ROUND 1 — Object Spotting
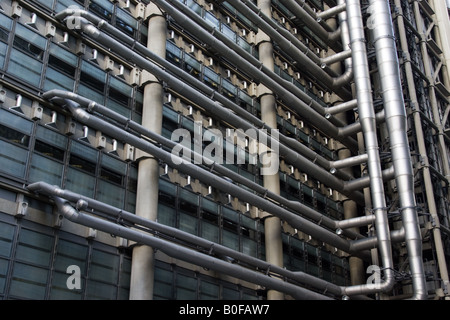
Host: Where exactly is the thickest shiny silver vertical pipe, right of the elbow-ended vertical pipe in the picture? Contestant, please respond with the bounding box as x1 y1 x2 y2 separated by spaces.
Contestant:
369 0 427 299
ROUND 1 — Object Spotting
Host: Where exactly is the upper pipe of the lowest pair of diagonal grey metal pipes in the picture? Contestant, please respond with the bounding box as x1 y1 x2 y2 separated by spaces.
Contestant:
27 182 342 296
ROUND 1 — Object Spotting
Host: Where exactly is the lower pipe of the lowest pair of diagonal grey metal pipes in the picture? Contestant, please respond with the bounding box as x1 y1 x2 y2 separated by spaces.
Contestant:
53 197 331 300
